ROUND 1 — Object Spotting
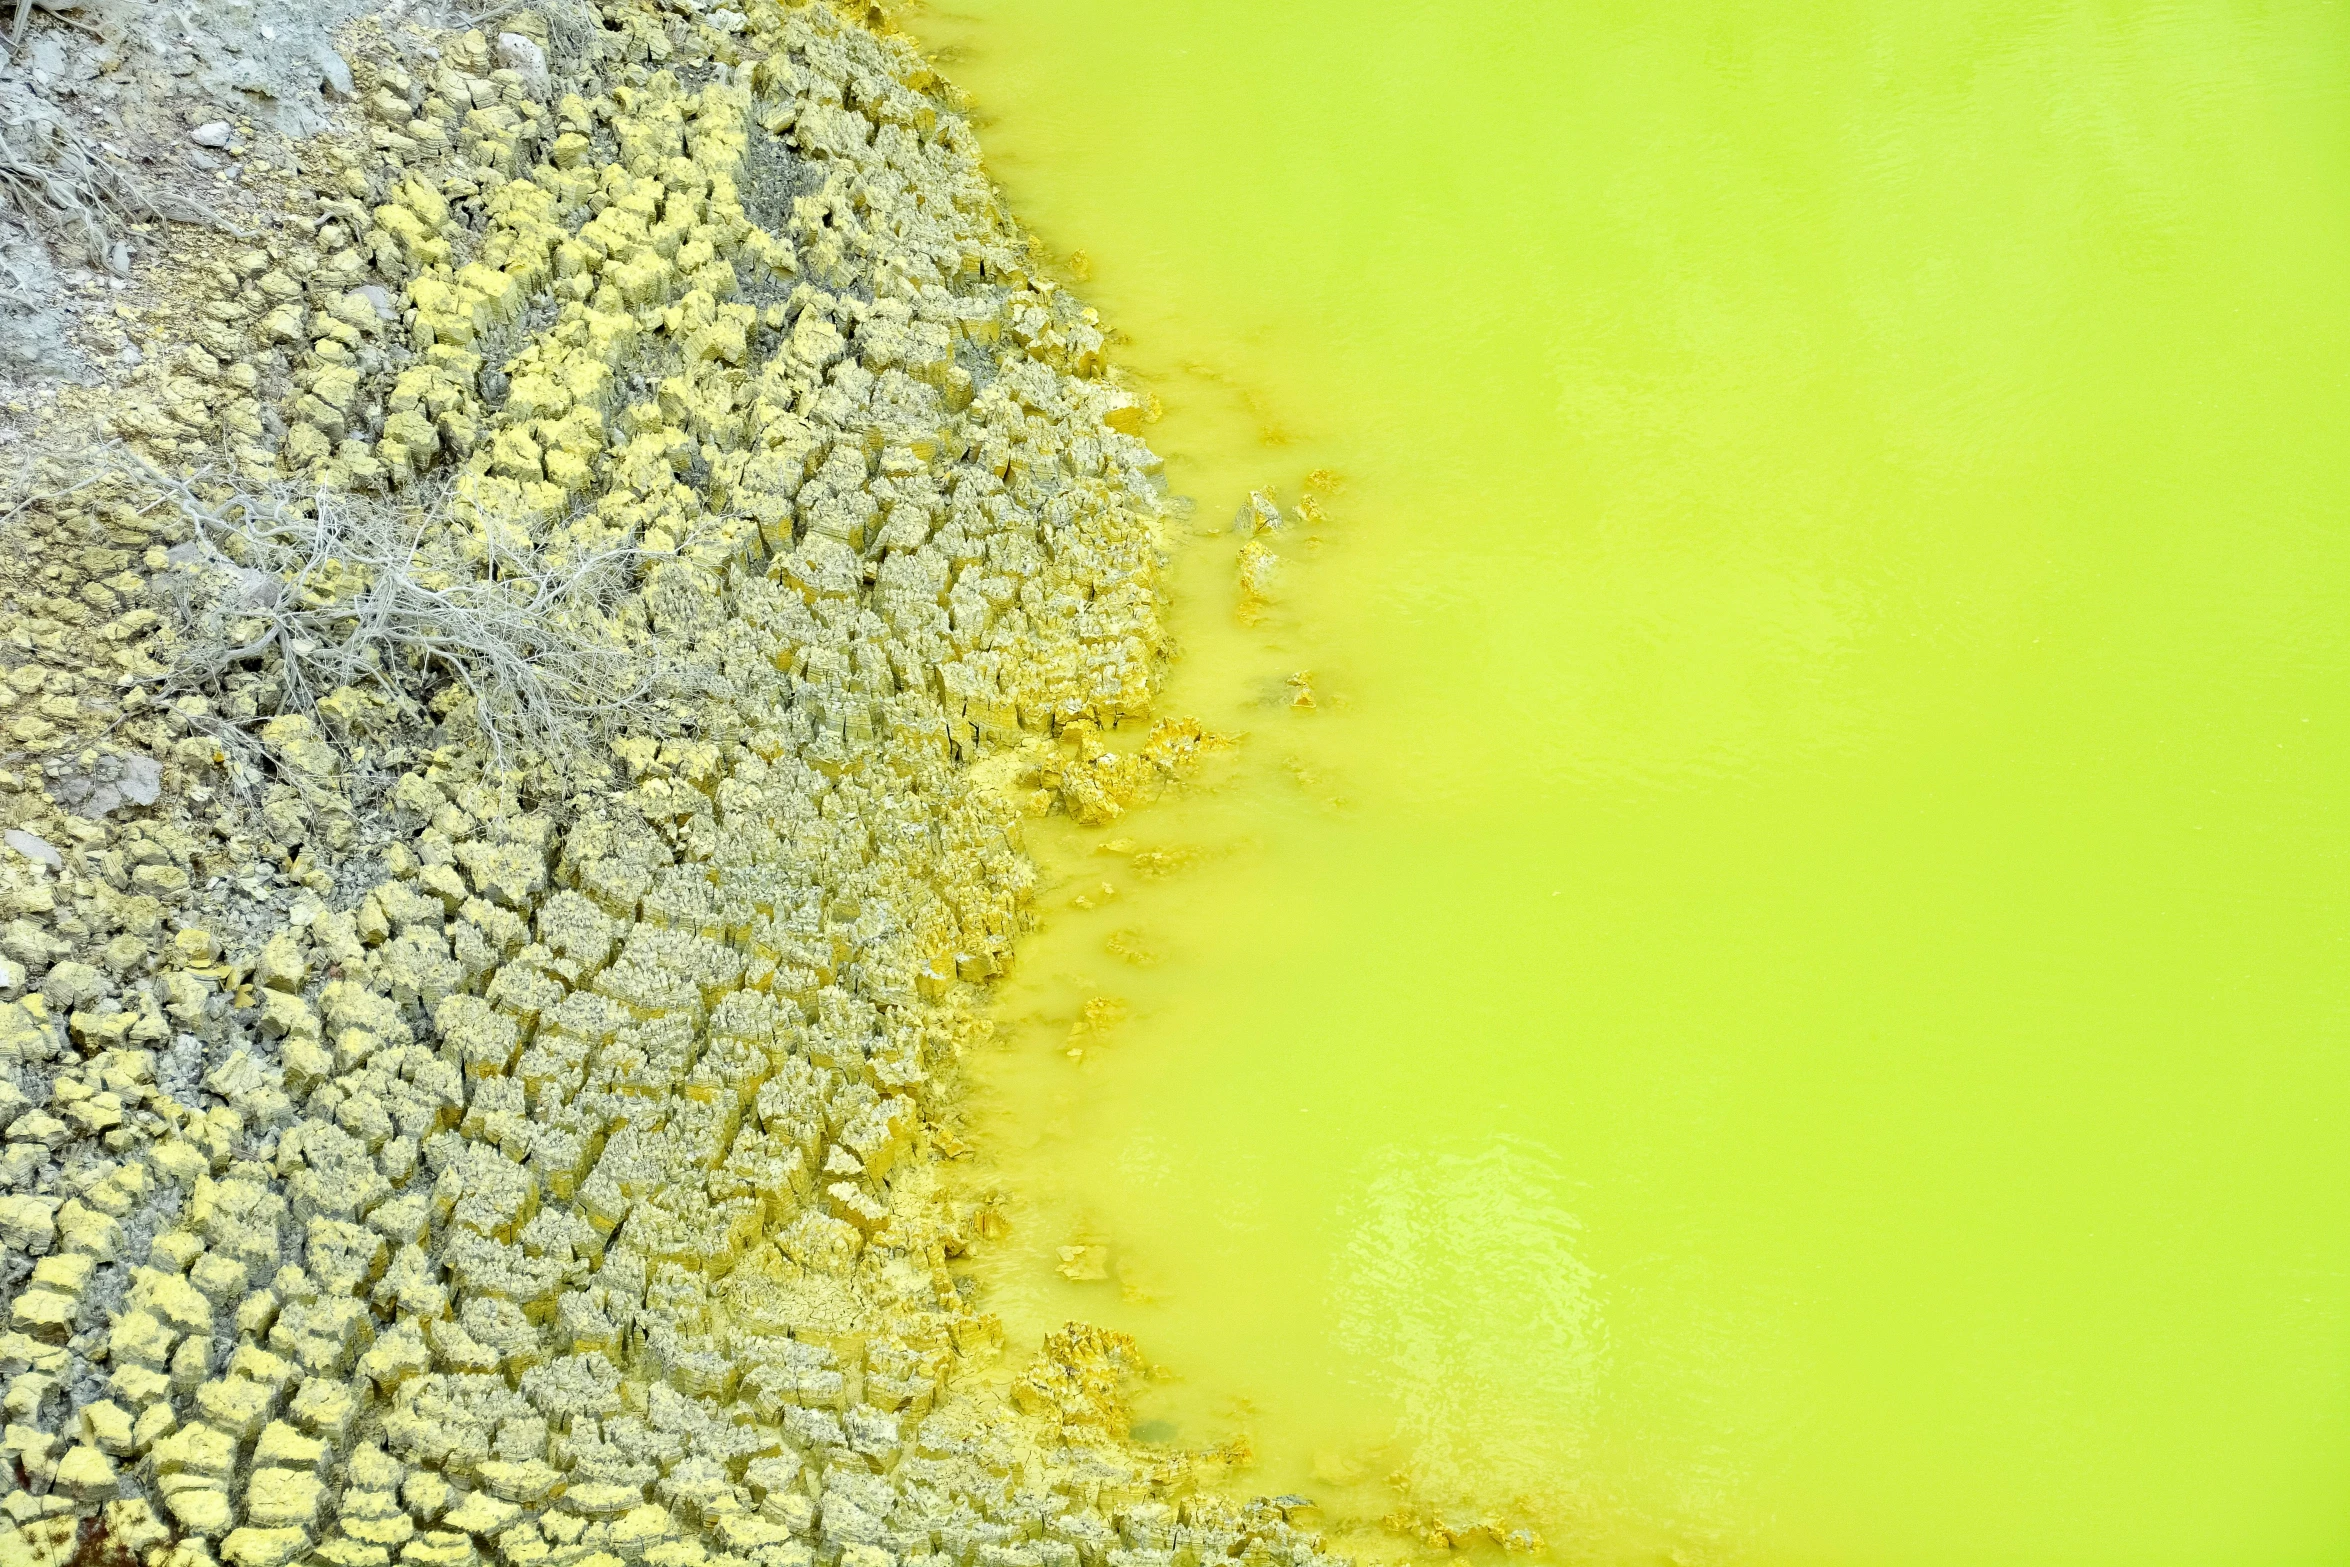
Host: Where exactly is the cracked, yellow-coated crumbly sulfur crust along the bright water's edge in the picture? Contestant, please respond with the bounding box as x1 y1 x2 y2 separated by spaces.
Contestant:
0 0 1353 1567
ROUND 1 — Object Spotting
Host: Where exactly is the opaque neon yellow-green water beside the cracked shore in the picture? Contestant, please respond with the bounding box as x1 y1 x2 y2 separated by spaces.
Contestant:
912 0 2350 1562
